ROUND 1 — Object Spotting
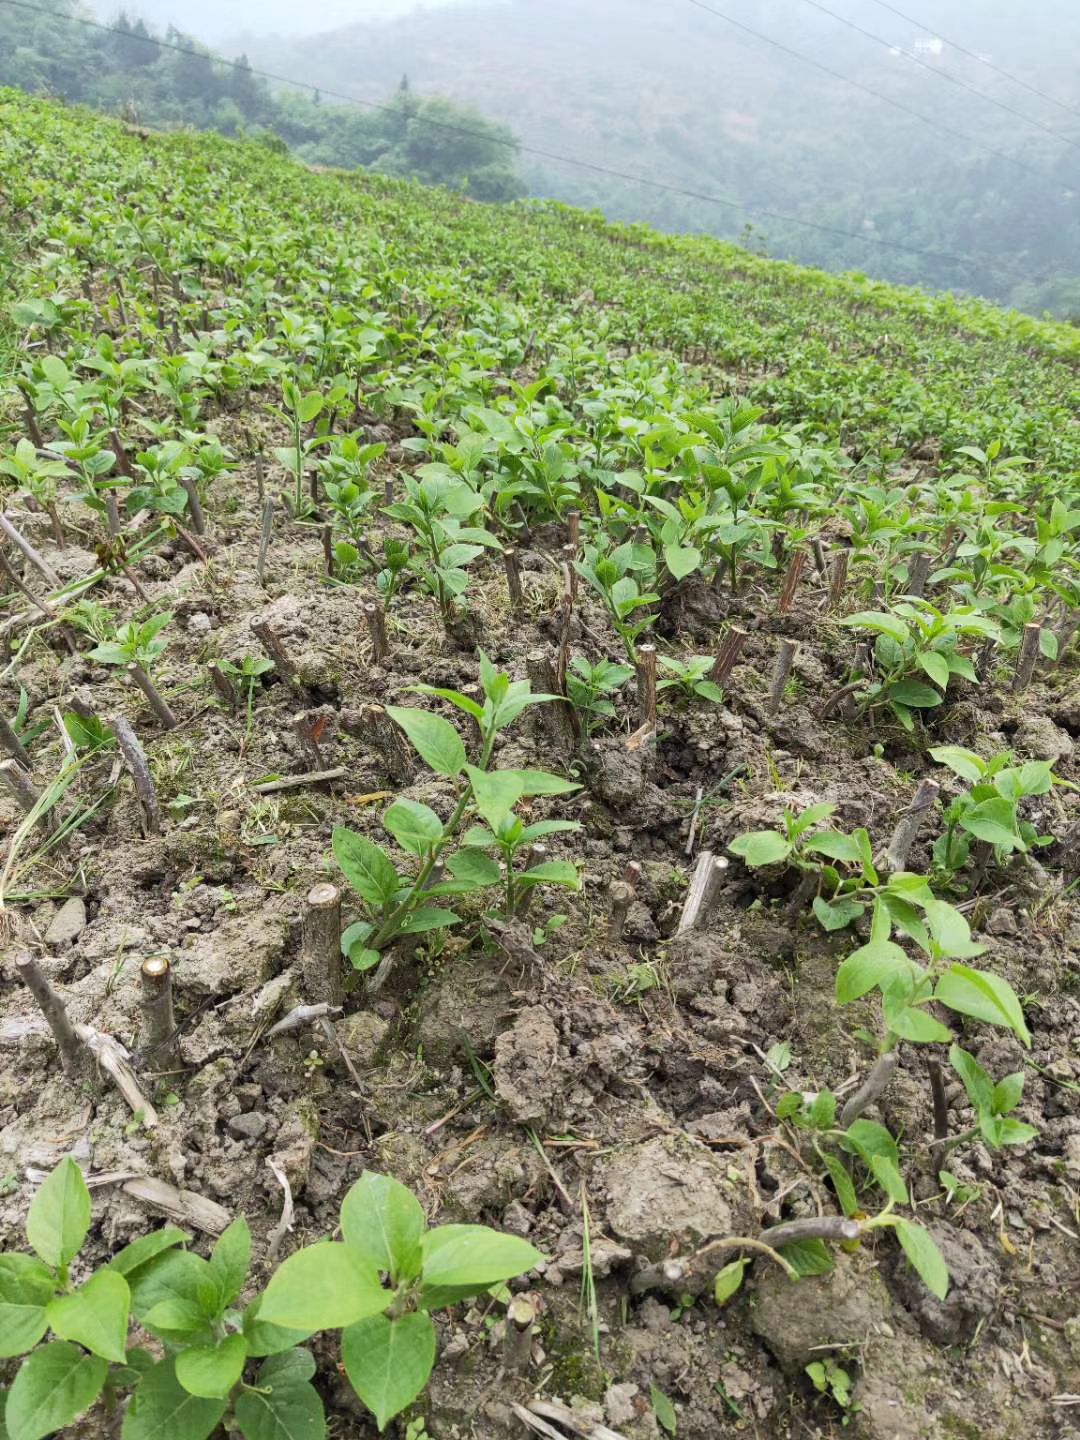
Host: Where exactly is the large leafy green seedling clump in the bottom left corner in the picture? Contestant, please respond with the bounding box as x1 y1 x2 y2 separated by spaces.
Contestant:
0 1159 543 1440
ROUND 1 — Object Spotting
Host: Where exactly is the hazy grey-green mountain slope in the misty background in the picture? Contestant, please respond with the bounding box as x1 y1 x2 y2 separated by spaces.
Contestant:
245 0 1080 317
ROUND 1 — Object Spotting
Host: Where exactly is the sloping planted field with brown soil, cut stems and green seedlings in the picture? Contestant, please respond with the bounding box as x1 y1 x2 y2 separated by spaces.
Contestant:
0 91 1080 1440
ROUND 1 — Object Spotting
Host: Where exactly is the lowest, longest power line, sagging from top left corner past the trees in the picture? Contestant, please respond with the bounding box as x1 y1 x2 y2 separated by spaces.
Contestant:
0 0 984 268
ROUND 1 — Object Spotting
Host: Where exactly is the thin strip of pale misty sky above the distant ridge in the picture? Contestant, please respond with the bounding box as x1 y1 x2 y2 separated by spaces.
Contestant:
89 0 472 43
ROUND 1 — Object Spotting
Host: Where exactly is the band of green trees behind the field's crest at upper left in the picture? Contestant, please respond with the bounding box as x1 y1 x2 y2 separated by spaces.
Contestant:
0 0 526 200
